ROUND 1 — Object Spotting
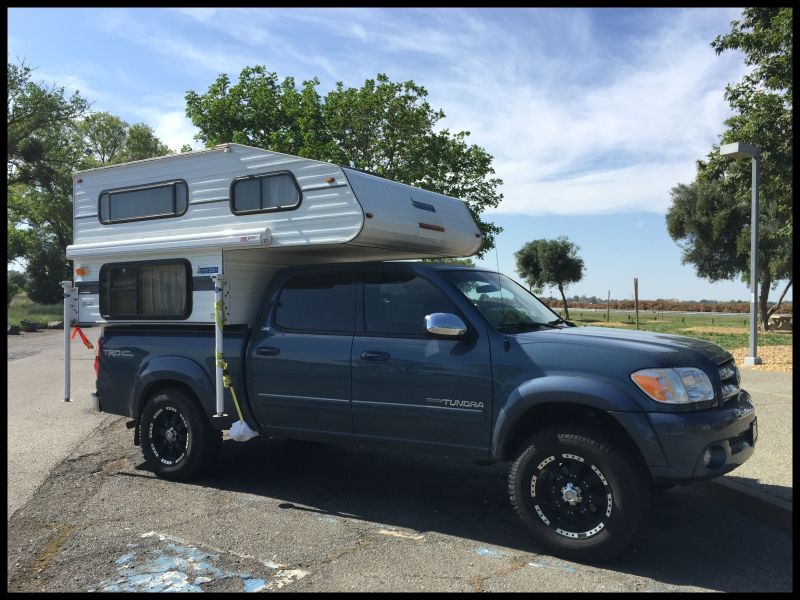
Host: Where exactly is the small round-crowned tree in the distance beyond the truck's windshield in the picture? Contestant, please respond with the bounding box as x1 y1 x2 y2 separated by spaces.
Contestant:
514 235 584 319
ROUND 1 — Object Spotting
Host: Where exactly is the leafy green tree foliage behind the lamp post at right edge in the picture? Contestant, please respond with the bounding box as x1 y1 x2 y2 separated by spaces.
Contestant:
666 7 793 328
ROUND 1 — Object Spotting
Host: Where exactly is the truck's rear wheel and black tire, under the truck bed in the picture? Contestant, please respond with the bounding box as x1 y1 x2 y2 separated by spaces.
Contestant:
141 388 222 481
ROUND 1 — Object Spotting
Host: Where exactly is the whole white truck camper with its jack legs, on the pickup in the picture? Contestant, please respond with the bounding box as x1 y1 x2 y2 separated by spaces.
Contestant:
62 144 481 422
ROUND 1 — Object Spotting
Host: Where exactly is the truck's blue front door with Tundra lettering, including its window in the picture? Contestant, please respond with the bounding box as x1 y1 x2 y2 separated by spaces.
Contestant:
352 272 492 458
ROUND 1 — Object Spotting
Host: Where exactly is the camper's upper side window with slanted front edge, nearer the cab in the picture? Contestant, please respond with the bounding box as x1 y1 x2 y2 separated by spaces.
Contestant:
231 171 302 214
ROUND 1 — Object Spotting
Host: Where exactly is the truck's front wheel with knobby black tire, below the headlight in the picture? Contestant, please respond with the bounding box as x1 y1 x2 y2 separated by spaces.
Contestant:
509 425 650 562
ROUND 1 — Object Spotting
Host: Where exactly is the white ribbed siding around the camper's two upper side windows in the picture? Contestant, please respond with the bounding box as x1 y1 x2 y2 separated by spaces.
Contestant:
67 144 364 260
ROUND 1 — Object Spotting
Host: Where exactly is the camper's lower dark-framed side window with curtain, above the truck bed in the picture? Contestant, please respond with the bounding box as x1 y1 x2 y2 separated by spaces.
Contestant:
100 259 191 319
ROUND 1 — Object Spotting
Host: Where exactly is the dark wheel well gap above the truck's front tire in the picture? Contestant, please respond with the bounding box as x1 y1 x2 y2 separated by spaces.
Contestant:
503 403 649 472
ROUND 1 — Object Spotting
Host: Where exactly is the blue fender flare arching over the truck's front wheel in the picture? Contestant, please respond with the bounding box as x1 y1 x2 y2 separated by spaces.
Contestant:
491 375 664 464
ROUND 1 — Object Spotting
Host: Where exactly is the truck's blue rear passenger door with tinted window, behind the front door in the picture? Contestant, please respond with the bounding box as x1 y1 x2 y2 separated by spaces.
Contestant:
247 273 355 441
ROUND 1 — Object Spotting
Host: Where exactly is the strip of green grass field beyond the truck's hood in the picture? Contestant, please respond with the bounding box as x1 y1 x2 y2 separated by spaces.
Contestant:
554 307 793 351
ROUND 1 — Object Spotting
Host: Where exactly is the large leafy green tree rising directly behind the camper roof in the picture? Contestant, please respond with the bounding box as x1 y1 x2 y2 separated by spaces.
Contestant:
186 66 503 256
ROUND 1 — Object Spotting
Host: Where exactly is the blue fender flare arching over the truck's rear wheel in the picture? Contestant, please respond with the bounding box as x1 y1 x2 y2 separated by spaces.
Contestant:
129 356 216 420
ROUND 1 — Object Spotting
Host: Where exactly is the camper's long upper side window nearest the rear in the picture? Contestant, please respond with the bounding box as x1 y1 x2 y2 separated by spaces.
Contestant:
97 181 189 225
